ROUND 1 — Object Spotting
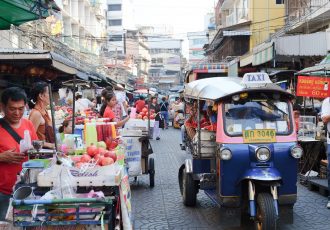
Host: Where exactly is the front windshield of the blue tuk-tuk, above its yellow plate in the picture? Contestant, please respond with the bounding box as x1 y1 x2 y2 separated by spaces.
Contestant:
224 99 292 136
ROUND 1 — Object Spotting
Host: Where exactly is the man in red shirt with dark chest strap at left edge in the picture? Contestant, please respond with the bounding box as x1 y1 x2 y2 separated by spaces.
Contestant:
0 87 38 221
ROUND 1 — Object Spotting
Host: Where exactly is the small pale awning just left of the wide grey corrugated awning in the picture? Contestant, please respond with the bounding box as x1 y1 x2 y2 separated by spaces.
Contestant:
252 42 274 66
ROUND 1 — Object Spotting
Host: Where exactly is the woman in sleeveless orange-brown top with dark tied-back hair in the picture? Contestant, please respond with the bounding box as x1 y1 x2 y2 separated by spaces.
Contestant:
29 81 55 149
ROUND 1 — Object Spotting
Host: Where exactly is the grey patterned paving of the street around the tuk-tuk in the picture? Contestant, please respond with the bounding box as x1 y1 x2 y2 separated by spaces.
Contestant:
131 128 330 230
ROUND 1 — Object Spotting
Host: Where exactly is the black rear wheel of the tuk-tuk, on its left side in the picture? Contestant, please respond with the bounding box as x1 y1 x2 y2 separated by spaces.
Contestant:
182 169 197 206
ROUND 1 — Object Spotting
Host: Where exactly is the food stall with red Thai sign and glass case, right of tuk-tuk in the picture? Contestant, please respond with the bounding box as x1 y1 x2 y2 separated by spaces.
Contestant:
295 65 330 194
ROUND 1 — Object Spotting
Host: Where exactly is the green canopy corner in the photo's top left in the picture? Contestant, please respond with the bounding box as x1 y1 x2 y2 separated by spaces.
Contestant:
0 0 60 30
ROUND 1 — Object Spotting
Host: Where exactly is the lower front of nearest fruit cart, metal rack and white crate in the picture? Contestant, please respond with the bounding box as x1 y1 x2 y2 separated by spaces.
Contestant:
12 154 130 229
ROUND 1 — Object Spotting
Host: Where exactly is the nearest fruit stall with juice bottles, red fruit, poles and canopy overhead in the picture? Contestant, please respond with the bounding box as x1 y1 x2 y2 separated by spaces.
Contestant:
0 49 136 229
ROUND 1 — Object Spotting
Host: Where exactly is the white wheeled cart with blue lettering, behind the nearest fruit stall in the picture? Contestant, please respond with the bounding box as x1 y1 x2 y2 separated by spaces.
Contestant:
121 119 155 187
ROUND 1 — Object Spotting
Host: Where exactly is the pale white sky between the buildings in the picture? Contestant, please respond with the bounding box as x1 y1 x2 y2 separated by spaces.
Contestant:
133 0 216 58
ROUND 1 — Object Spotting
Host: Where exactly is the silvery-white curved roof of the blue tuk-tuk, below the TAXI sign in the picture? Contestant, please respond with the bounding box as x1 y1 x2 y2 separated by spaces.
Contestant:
184 77 294 101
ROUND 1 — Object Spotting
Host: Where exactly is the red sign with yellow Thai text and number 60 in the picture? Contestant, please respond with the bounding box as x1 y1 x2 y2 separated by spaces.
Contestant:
297 76 330 98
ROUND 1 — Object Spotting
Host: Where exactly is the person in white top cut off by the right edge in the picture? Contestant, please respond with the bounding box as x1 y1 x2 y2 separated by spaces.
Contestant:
321 97 330 209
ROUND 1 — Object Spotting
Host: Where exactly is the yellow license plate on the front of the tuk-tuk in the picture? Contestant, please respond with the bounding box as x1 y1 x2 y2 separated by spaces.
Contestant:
243 129 276 143
